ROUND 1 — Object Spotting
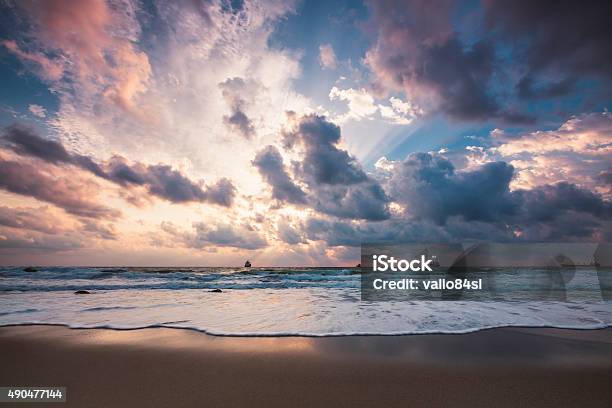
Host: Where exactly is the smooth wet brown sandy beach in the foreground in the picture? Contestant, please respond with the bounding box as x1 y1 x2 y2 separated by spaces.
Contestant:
0 326 612 407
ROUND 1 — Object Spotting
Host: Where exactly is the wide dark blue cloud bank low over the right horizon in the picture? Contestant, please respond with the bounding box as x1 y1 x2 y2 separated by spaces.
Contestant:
302 153 612 246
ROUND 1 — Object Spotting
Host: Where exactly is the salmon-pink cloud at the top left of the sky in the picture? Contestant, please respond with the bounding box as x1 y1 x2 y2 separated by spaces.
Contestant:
4 0 151 111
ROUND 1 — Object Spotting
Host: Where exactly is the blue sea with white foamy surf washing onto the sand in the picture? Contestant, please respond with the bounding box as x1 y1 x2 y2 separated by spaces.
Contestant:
0 267 612 336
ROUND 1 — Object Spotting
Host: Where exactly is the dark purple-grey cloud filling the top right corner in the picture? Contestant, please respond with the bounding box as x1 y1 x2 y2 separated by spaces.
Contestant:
484 0 612 97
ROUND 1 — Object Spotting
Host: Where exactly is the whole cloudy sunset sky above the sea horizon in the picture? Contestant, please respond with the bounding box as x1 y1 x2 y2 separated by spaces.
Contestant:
0 0 612 266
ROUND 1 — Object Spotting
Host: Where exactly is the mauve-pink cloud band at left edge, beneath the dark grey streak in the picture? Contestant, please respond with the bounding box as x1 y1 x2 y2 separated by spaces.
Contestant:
0 161 120 218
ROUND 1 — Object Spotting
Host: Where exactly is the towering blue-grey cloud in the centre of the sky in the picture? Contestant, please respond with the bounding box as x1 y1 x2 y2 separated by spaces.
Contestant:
278 115 389 221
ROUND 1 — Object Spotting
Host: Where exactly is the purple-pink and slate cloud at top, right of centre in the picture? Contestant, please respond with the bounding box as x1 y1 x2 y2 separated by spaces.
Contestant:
366 0 507 120
